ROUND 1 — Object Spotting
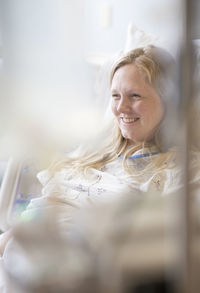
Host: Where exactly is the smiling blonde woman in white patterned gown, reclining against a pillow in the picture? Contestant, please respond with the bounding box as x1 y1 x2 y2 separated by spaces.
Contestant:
0 46 198 250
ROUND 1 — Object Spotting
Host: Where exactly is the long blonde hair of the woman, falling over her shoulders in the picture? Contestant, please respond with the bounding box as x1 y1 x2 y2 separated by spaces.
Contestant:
49 45 177 175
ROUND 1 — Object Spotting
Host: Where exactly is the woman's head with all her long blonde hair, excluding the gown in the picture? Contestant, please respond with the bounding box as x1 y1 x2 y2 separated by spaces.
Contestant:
29 45 177 180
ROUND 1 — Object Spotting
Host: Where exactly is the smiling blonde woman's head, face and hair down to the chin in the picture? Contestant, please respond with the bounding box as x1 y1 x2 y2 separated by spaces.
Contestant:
111 46 177 153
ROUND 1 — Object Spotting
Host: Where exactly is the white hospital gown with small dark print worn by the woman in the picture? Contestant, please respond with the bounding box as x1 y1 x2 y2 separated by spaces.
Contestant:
22 150 200 229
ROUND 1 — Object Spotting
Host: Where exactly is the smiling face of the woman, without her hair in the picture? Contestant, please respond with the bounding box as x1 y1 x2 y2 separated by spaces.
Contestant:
111 64 164 144
